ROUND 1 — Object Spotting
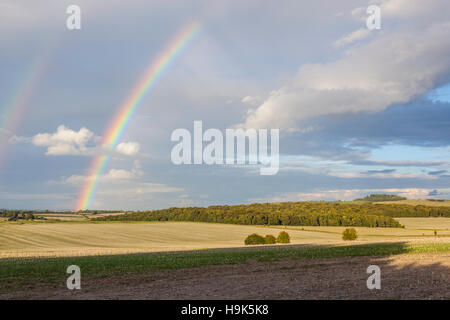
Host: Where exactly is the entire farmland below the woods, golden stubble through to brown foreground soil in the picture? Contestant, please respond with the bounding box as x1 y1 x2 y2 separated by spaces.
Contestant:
0 218 450 299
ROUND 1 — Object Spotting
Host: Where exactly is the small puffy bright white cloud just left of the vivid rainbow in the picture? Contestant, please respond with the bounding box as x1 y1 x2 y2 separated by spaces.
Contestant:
32 125 94 155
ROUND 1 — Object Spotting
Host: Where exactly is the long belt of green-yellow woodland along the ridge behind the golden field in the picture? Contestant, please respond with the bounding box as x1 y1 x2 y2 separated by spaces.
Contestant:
90 202 450 228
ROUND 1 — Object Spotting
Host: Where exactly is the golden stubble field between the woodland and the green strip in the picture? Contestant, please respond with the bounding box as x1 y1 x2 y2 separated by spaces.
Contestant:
0 218 450 258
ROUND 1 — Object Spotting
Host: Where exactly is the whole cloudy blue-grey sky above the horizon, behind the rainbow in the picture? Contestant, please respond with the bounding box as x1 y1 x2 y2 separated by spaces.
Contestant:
0 0 450 210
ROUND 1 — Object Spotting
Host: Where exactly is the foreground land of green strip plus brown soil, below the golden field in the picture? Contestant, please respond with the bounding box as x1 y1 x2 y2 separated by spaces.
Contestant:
0 243 450 299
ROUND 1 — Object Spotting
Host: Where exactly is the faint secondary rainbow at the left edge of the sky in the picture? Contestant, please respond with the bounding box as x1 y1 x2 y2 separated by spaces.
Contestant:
0 55 47 172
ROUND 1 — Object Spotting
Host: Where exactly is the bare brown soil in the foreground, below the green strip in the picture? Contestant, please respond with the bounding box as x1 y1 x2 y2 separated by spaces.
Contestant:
0 252 450 299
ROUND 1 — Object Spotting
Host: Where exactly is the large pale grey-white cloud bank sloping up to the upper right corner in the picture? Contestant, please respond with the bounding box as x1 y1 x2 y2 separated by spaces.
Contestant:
244 0 450 129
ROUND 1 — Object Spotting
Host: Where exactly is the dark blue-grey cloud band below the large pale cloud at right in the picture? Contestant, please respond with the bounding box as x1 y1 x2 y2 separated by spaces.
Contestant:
281 99 450 160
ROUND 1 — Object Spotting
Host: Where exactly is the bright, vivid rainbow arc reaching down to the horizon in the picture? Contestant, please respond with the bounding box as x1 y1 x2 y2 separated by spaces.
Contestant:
76 22 200 211
